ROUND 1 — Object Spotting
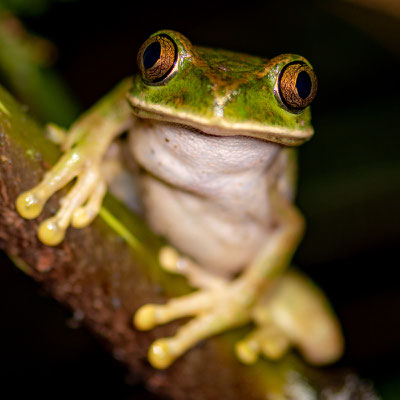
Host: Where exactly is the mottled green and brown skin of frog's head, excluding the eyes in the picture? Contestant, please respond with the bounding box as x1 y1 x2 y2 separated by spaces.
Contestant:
128 31 312 144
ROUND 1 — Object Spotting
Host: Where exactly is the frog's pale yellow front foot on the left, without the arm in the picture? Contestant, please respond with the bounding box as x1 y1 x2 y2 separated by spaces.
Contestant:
16 146 106 246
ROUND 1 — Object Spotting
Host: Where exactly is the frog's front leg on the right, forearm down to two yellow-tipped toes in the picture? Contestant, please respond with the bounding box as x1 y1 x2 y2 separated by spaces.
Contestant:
135 188 303 368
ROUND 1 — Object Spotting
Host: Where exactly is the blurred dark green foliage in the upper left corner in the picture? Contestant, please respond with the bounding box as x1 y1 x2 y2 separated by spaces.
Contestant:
0 8 78 125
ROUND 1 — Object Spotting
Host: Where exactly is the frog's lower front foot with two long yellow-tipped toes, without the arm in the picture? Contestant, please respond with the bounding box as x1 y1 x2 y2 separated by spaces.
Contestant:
134 283 252 369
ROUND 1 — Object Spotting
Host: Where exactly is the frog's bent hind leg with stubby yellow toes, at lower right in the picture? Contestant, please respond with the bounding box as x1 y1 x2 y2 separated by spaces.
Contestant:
235 269 343 365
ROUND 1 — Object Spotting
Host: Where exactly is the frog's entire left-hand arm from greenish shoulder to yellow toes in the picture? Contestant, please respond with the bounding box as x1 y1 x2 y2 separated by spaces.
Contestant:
16 79 132 245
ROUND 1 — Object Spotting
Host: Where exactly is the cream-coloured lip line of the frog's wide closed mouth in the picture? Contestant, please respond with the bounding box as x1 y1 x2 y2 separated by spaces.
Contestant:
129 96 314 146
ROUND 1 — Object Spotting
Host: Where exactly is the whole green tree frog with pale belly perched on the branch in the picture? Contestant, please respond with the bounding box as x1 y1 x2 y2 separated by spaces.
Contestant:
16 30 343 369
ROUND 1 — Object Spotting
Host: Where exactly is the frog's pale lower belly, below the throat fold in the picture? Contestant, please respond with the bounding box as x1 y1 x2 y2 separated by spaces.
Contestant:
142 175 268 276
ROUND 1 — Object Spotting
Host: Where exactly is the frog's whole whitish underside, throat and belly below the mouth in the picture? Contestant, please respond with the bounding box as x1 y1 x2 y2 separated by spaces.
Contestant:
130 120 280 275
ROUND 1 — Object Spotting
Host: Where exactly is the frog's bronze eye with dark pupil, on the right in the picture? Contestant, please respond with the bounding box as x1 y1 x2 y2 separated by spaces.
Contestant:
278 61 318 112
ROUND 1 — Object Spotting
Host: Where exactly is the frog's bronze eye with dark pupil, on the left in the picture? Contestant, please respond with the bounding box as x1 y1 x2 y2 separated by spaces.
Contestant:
137 35 178 84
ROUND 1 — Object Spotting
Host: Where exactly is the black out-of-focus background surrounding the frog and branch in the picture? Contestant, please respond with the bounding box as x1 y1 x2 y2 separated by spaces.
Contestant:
0 0 400 400
